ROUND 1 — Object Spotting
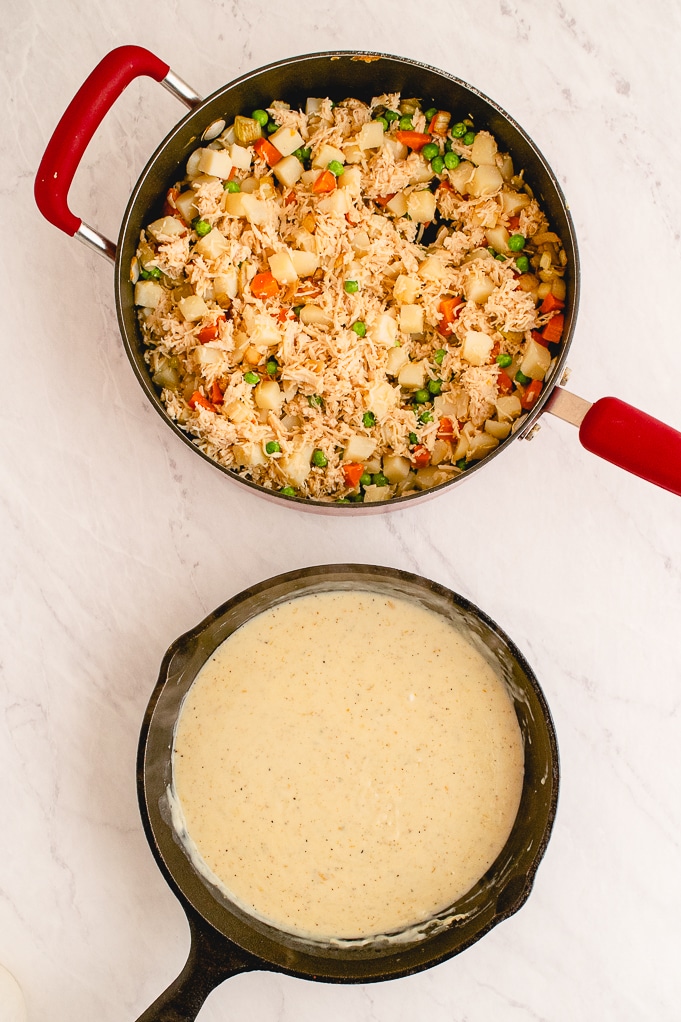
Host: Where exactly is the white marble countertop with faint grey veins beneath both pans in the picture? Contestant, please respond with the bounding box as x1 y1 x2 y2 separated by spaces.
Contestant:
0 0 681 1022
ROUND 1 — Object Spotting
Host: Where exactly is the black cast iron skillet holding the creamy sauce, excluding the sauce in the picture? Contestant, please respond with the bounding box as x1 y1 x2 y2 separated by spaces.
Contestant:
137 564 558 1022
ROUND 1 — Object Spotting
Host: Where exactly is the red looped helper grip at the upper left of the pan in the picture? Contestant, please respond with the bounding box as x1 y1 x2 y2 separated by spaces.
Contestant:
34 46 170 237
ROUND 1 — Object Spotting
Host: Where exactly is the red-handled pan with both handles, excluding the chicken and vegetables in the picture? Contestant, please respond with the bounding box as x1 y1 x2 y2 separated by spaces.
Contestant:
35 46 681 506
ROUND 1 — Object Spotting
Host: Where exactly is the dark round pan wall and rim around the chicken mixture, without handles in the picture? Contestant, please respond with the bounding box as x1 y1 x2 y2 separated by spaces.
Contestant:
116 52 579 513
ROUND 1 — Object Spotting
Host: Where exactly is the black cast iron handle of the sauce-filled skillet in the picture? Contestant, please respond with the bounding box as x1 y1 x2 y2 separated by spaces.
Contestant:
137 913 263 1022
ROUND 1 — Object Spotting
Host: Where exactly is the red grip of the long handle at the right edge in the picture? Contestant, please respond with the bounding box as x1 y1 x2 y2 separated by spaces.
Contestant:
580 398 681 497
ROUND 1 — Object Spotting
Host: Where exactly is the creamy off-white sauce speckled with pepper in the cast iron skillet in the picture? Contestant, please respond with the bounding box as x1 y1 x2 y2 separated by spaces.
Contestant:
173 592 524 939
